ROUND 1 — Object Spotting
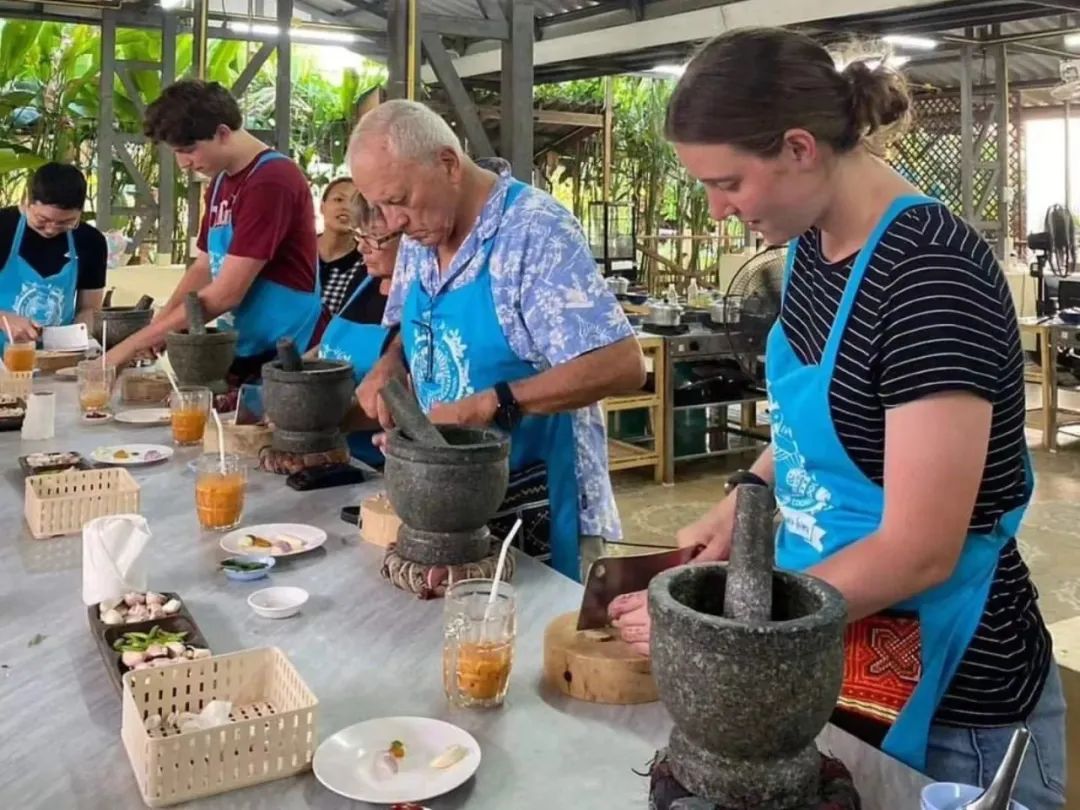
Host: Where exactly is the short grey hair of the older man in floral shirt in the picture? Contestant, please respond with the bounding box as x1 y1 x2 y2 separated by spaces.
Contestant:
349 98 462 162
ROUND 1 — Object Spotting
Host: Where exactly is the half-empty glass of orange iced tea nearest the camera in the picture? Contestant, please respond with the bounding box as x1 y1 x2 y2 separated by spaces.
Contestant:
443 579 517 708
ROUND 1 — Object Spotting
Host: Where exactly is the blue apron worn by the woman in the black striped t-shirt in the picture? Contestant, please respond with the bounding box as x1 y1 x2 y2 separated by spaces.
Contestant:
766 195 1031 770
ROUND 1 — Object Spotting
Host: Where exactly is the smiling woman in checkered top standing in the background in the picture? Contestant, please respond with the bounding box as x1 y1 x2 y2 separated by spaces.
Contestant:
319 177 365 315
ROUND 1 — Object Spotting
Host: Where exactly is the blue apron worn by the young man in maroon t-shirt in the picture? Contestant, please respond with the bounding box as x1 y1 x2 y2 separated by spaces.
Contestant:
206 152 323 357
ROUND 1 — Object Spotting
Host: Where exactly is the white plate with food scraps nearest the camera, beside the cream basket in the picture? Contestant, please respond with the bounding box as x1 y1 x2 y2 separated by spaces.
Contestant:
312 717 481 805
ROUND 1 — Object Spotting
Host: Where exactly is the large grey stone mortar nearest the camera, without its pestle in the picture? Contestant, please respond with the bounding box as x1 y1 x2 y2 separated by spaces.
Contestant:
649 564 847 810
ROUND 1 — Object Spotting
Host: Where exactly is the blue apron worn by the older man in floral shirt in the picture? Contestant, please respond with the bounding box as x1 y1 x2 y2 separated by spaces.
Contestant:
402 180 581 580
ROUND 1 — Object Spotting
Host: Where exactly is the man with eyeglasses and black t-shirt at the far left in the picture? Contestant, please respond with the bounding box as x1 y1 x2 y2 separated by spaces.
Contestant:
0 163 108 348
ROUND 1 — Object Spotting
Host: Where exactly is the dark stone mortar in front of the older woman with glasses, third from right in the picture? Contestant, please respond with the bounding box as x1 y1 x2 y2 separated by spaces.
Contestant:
262 360 355 453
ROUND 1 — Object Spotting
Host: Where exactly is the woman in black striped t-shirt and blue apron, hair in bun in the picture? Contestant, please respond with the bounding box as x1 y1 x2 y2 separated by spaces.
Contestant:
610 29 1065 810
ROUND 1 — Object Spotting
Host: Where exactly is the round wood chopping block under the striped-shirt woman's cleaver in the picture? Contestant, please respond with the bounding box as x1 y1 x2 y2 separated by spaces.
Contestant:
543 611 658 705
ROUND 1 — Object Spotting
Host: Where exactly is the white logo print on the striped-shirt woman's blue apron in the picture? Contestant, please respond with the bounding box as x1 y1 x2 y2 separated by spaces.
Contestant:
769 400 833 553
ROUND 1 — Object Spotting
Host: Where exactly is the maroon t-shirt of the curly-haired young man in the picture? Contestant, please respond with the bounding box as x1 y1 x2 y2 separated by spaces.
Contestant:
199 150 319 291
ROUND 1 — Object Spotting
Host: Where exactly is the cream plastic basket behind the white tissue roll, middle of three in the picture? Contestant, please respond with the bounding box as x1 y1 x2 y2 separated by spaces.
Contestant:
26 468 139 540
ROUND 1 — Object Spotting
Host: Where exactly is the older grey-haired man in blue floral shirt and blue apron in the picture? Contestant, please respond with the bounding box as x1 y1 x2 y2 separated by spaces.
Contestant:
350 100 645 578
